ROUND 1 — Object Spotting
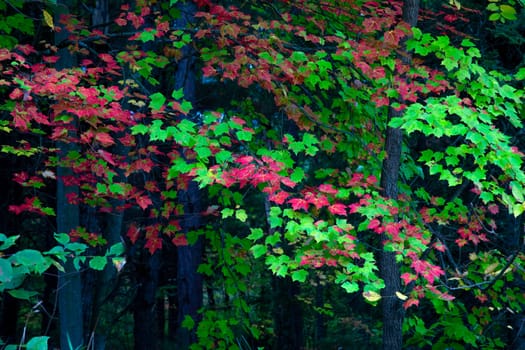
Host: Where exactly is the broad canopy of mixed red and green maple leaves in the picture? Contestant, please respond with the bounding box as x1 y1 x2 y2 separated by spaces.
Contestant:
0 1 525 347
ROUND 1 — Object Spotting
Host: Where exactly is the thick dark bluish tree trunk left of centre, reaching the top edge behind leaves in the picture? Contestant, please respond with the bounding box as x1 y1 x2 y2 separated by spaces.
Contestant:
174 1 203 349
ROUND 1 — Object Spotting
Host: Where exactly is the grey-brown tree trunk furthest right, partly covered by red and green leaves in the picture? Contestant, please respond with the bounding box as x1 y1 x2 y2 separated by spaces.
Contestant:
380 0 419 350
